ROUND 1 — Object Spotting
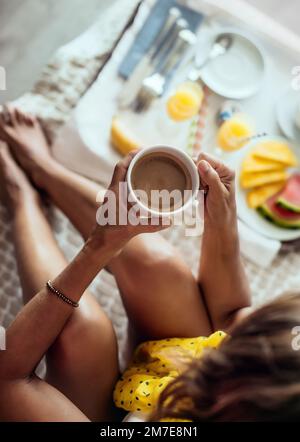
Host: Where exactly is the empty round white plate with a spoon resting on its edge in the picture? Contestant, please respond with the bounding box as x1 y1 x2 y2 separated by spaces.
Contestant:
201 31 265 99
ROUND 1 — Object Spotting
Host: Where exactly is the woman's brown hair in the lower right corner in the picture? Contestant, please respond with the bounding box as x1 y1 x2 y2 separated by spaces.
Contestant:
153 294 300 422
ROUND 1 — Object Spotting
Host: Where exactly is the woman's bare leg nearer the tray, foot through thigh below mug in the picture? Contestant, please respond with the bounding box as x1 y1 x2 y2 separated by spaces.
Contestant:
0 110 211 338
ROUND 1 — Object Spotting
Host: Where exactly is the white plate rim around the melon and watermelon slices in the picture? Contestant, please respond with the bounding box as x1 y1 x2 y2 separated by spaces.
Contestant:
231 137 300 241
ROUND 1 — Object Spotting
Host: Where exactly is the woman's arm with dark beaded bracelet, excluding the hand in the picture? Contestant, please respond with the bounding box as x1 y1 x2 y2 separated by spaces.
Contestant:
0 229 126 379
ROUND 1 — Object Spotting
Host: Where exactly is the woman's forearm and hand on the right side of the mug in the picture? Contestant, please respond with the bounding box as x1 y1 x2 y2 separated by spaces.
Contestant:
198 154 251 329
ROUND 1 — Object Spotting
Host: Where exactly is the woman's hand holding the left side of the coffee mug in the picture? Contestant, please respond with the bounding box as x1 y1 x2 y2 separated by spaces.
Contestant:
93 151 170 242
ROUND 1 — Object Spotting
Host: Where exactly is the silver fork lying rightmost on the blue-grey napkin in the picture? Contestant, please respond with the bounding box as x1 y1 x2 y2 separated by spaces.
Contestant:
133 29 196 112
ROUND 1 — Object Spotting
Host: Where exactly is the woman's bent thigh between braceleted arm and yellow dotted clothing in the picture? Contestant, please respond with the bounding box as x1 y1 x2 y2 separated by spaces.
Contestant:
46 293 119 421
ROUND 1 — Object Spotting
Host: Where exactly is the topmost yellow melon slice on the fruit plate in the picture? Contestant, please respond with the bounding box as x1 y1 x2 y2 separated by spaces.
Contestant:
253 141 297 167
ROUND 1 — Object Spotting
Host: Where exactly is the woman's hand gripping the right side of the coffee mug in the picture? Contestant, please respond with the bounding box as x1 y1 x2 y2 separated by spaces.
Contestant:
197 153 236 227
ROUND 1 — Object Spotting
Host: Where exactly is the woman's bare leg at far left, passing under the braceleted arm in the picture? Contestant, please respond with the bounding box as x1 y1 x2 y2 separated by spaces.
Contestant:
0 147 118 420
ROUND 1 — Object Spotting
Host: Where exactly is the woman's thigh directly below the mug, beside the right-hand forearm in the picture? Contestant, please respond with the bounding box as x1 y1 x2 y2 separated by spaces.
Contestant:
109 233 211 339
